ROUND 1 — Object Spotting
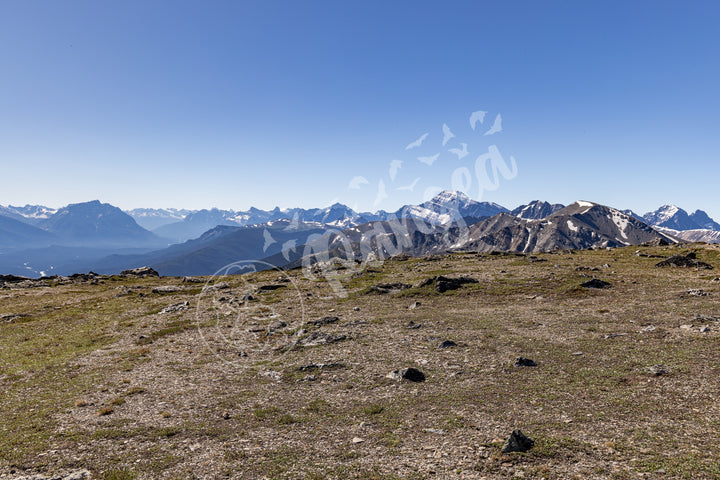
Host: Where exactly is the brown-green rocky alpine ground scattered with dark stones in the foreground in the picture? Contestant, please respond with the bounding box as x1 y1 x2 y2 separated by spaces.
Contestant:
0 244 720 480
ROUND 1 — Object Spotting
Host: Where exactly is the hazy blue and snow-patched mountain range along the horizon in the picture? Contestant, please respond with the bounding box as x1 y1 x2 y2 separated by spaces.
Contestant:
0 191 720 276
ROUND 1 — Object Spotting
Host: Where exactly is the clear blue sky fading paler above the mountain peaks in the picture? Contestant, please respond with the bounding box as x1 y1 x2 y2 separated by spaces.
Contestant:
0 0 720 219
